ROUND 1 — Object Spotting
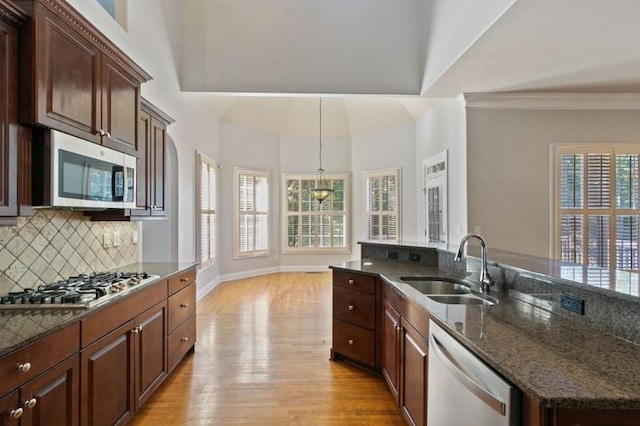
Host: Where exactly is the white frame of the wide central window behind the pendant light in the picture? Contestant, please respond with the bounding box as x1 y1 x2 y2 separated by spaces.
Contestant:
280 173 351 254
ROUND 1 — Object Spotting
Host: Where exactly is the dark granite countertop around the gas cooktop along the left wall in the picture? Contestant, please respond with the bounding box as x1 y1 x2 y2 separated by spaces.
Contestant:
0 262 195 357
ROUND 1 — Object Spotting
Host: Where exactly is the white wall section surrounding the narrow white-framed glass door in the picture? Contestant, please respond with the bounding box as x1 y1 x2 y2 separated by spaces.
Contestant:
415 98 467 244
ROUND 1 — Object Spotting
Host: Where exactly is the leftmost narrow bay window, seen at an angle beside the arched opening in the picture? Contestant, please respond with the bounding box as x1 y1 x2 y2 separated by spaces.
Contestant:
196 152 218 268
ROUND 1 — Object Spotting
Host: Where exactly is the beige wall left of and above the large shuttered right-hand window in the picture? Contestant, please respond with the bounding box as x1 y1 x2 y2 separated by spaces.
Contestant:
467 109 640 257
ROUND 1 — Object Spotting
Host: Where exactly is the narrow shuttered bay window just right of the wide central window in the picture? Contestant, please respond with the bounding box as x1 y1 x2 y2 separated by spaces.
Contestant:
364 168 400 241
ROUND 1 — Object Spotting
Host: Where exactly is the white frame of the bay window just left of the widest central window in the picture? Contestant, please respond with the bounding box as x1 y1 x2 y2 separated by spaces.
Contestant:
233 167 271 259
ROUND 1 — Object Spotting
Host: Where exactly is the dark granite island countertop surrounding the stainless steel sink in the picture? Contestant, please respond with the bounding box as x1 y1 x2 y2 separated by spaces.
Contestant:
331 259 640 409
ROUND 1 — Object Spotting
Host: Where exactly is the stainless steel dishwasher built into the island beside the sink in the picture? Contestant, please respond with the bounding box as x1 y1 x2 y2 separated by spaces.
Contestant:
427 321 521 426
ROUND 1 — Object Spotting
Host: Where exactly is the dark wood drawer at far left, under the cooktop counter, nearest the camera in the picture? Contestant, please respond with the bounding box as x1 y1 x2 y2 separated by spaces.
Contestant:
0 323 80 395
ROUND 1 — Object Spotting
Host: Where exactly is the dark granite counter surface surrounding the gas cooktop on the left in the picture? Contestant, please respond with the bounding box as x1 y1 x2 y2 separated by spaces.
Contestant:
0 262 197 358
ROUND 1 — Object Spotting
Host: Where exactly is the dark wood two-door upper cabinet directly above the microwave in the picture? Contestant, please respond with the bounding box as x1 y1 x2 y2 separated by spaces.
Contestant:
17 0 151 155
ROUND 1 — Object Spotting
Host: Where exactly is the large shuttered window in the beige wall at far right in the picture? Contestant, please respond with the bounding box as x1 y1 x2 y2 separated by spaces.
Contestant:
554 145 640 271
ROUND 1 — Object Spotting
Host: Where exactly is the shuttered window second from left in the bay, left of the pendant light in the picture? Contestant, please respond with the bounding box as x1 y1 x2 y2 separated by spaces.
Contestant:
234 167 269 257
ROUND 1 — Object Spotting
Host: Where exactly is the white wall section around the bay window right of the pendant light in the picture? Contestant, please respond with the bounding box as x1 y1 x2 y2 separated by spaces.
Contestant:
351 123 418 253
